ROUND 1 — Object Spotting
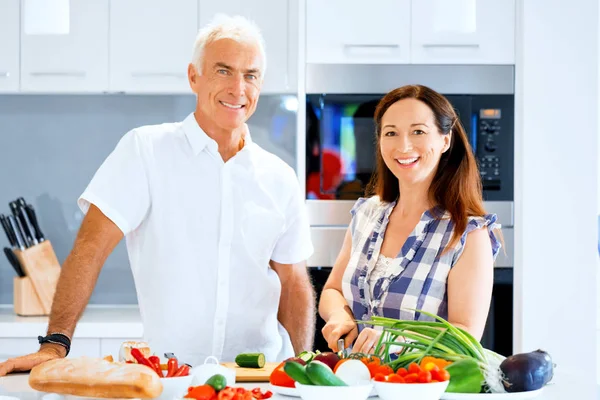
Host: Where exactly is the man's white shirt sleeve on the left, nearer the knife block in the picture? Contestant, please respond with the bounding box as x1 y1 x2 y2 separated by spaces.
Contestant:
77 131 150 235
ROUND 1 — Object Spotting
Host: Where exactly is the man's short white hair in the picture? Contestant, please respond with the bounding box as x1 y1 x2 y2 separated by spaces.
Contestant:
192 14 267 76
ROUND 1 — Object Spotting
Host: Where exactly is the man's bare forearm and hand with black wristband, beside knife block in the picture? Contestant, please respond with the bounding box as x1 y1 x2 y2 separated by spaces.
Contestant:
0 205 123 376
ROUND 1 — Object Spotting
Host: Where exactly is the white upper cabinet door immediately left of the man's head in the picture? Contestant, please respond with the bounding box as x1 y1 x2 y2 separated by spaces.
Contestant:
110 0 198 93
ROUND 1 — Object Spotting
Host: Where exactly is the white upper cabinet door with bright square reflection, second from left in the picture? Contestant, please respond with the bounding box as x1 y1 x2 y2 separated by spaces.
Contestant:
21 0 109 93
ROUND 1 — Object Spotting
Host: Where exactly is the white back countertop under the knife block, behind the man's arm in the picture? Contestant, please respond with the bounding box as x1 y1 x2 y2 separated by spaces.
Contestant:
0 305 143 338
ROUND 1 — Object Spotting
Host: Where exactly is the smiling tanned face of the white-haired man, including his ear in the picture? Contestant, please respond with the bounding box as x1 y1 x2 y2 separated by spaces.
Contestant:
188 39 263 130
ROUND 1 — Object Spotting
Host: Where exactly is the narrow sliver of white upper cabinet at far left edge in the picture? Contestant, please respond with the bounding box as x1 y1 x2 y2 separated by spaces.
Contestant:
0 0 20 93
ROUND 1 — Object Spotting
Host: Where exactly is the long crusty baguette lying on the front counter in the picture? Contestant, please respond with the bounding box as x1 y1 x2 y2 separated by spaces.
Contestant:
29 357 163 399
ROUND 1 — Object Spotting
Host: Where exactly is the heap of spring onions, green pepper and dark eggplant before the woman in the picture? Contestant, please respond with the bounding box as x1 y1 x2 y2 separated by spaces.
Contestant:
357 310 554 393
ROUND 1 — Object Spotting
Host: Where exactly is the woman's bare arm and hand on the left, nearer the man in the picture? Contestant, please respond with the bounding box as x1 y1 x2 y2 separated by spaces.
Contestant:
319 228 358 351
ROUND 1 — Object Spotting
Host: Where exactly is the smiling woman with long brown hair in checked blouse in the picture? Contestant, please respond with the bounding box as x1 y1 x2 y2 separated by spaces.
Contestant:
319 86 500 353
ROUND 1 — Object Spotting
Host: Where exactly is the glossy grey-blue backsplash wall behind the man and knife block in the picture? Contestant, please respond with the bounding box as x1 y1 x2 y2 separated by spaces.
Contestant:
0 95 296 304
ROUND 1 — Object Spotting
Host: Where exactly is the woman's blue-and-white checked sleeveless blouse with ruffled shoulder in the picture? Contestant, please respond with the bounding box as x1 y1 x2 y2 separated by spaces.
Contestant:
342 196 501 329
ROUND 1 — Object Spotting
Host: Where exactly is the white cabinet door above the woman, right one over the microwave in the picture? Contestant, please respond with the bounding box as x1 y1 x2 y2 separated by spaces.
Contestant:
411 0 515 64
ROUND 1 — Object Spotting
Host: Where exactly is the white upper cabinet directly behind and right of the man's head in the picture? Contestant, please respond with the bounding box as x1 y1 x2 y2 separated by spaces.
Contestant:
198 0 298 93
